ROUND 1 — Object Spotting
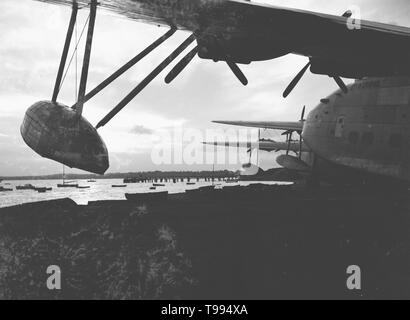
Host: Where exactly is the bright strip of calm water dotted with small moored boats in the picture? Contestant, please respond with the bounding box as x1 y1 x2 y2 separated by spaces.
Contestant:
0 179 290 208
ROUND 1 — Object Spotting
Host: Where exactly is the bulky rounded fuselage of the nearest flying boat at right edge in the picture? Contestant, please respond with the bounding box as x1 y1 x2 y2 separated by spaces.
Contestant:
302 77 410 182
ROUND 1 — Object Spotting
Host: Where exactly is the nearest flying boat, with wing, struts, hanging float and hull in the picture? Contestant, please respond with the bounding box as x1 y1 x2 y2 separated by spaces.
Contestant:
21 0 410 181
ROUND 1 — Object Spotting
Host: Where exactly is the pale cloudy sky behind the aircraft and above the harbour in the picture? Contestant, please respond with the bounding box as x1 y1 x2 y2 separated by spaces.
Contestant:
0 0 410 176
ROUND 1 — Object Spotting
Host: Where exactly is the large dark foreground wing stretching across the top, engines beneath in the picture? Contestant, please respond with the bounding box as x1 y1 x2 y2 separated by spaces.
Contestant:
33 0 410 78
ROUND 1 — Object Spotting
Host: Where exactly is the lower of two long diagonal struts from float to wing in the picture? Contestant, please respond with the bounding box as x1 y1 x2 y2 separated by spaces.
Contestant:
97 34 195 129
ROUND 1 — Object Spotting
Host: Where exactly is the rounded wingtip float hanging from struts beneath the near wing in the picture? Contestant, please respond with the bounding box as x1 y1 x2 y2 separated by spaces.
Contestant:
20 101 109 174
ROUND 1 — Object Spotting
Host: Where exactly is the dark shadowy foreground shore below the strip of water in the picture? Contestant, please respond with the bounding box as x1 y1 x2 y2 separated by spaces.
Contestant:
0 187 410 299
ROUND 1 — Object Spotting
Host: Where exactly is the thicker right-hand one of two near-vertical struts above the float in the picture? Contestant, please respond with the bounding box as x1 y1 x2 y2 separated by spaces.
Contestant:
76 0 98 116
